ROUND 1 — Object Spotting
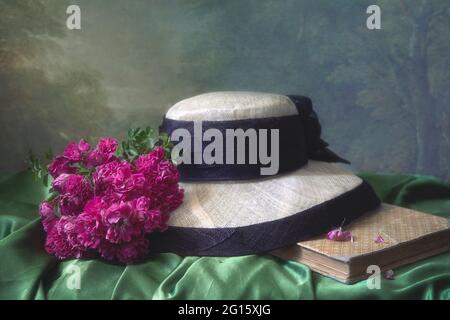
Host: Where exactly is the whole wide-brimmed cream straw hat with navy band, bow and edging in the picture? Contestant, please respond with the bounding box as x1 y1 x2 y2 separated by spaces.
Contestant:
152 92 380 256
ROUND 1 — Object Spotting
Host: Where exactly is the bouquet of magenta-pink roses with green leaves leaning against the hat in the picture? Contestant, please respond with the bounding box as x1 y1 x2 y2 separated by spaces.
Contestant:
32 129 183 263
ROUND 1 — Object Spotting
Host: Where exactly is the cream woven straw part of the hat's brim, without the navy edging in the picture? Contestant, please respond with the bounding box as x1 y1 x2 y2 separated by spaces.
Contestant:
169 161 362 228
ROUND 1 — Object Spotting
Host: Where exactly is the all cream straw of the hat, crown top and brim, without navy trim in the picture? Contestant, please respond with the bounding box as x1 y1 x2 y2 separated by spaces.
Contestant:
166 92 362 228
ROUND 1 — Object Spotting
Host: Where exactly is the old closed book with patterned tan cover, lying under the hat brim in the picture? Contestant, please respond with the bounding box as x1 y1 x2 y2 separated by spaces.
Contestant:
272 204 450 283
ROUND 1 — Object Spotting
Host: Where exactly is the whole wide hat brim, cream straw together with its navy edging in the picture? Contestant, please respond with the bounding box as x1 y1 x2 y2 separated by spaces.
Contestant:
151 161 380 256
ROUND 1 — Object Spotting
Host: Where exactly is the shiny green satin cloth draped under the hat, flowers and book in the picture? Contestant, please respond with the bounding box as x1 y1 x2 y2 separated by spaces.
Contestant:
0 172 450 300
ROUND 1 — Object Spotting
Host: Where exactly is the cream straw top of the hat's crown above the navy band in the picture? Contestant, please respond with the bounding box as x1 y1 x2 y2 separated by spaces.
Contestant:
166 91 298 121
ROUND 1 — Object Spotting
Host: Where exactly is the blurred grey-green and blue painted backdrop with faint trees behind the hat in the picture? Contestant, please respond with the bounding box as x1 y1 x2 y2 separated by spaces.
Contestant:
0 0 450 180
